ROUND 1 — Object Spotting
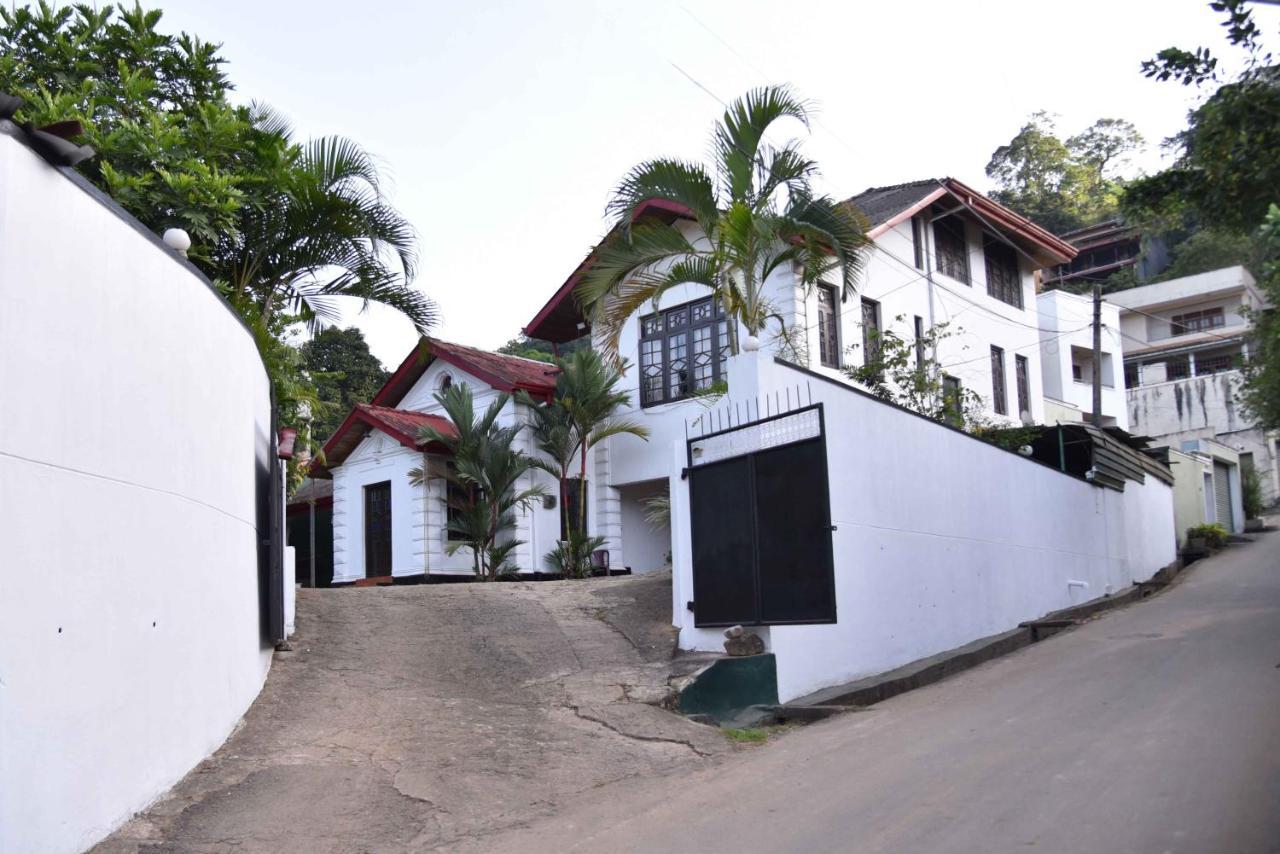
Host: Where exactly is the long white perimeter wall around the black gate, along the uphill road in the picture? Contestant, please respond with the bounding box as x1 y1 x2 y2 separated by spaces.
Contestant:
667 356 1176 702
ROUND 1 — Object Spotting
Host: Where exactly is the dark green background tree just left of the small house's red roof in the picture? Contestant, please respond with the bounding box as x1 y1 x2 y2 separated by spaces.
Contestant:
298 326 390 443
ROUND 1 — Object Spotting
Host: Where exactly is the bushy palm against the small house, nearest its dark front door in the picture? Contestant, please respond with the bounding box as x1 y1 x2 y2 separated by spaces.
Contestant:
408 384 543 581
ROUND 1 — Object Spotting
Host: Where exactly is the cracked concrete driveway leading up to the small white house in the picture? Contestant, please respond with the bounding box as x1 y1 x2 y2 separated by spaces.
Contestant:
95 575 733 854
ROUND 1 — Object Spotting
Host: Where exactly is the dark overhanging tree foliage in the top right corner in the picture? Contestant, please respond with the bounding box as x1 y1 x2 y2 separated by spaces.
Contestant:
1123 0 1280 234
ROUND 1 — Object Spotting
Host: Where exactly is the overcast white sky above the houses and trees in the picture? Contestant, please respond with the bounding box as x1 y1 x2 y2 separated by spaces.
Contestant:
148 0 1272 366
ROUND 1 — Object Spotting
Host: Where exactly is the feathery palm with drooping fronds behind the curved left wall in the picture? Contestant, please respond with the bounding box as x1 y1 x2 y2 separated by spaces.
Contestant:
215 112 436 333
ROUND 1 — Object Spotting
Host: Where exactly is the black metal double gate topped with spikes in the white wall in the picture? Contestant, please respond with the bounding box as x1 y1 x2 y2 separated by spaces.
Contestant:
689 403 836 627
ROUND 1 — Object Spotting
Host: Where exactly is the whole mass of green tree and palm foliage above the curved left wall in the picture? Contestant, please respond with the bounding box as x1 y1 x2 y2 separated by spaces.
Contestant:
0 0 435 448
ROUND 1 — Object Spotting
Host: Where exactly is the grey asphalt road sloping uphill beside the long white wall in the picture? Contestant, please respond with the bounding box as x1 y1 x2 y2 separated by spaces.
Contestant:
477 533 1280 854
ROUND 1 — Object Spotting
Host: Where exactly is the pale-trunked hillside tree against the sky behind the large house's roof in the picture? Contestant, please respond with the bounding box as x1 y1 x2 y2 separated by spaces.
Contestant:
987 111 1143 233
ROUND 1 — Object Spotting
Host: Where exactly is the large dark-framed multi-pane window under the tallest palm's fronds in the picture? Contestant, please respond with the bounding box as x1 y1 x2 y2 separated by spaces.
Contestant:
640 297 728 406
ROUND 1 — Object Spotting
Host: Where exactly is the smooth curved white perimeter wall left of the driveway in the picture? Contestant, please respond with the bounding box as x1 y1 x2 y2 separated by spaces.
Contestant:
0 123 274 854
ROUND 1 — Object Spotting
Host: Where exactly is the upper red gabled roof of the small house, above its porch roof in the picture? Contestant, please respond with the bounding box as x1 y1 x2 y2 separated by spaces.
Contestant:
372 338 559 406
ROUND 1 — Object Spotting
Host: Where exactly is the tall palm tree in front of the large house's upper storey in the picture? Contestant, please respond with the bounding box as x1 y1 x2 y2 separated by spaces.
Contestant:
576 86 868 357
